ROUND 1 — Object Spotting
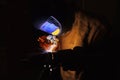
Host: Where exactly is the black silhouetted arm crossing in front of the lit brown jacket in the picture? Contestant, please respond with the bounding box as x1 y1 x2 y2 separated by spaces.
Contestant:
54 47 104 70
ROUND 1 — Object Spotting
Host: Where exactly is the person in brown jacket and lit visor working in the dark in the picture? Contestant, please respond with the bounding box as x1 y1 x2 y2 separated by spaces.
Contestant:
26 0 109 80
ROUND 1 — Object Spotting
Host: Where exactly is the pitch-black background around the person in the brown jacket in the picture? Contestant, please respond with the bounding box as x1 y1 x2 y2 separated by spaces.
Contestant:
0 0 120 80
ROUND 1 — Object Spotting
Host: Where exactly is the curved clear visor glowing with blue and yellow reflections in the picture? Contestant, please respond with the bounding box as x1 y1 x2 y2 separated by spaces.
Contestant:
33 16 62 36
